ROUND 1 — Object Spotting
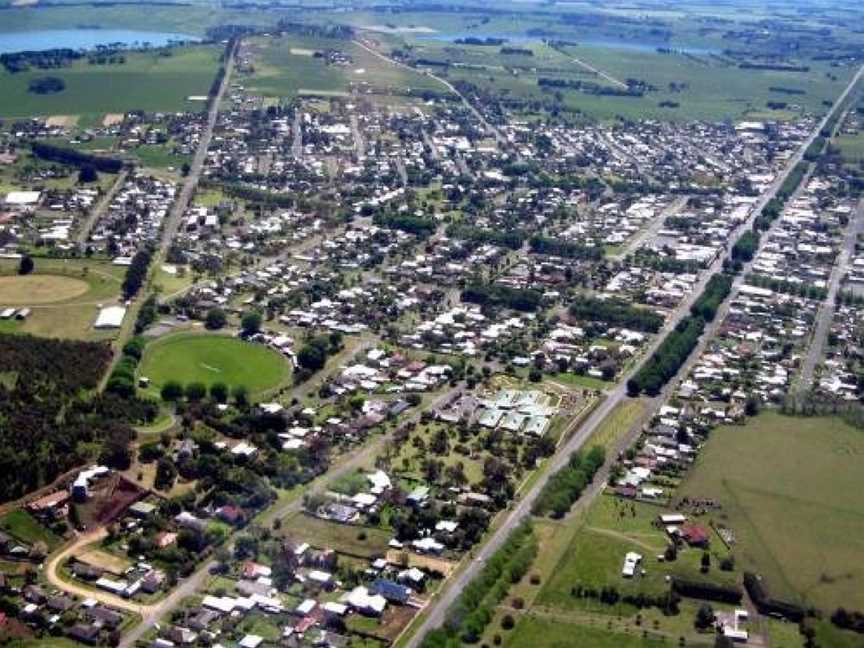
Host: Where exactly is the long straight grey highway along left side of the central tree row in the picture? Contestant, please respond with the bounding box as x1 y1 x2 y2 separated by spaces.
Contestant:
406 66 864 648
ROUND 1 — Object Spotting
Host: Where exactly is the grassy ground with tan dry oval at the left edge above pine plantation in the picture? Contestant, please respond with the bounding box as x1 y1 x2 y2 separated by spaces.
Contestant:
0 258 126 340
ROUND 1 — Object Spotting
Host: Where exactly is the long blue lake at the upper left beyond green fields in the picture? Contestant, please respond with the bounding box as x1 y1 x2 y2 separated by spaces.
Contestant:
0 29 201 54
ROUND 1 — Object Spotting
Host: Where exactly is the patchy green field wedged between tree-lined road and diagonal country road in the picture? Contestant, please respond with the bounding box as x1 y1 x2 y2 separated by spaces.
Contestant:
245 36 444 99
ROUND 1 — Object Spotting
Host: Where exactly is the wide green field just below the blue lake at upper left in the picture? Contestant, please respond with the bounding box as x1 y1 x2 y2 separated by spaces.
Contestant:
0 45 220 118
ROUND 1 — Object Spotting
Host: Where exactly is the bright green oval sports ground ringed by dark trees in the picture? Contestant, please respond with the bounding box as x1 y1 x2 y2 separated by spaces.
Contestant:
139 333 290 394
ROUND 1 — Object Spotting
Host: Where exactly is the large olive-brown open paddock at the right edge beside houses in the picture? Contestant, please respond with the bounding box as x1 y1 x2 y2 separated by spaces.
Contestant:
678 412 864 612
